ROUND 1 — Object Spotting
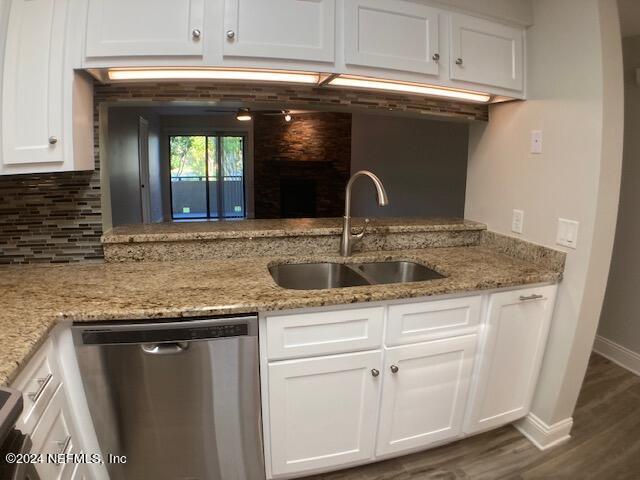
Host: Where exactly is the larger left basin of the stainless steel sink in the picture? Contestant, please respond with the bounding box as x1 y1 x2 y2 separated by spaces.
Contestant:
269 263 369 290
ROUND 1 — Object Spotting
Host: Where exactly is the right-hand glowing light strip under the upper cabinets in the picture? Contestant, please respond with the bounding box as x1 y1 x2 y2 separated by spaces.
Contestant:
328 75 491 103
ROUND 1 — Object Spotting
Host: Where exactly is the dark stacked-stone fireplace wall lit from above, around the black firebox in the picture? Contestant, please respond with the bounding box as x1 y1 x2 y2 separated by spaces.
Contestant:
253 112 351 218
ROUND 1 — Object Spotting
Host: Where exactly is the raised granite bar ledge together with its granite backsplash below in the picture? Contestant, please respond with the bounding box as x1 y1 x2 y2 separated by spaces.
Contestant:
102 218 486 262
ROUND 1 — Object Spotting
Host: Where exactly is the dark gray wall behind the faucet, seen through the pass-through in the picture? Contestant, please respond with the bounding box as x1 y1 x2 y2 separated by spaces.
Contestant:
351 114 469 217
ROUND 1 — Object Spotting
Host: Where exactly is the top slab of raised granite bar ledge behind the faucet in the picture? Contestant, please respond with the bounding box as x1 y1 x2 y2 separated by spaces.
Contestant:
102 217 487 243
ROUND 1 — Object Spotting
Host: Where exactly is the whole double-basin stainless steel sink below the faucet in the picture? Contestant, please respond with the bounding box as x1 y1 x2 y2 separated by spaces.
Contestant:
269 261 444 290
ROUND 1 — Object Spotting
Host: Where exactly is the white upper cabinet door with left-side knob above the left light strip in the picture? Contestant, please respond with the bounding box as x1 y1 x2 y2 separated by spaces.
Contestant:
223 0 335 62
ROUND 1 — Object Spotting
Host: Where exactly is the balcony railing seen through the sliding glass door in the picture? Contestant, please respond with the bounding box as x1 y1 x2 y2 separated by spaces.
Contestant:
171 175 245 219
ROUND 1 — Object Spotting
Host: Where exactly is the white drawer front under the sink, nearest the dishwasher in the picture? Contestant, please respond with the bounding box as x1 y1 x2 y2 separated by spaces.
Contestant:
266 307 384 360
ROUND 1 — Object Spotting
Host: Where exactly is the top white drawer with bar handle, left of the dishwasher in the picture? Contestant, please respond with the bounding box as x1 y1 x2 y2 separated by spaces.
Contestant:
13 340 61 433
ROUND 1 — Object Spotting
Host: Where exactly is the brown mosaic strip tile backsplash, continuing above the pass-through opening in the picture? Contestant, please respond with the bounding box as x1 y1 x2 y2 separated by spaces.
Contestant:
0 82 489 264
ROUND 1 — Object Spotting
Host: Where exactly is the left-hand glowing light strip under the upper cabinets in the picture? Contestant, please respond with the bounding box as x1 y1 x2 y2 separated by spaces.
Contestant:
108 68 320 84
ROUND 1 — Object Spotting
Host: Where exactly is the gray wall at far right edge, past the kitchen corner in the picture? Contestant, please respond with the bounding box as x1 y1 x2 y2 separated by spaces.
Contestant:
598 36 640 353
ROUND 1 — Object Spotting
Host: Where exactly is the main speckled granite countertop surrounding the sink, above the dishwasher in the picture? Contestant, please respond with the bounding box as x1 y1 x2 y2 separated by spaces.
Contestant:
0 246 561 385
